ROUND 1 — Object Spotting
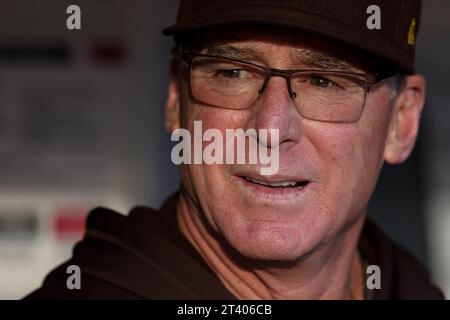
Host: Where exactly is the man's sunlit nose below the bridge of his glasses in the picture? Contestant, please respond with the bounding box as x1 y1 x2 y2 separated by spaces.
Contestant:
251 76 301 148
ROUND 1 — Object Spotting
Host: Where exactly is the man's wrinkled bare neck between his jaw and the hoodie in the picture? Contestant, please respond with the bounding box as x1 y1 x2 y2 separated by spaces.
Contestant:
177 193 364 300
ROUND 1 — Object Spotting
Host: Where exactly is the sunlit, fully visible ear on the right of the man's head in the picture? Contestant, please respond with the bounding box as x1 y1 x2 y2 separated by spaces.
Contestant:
384 75 426 164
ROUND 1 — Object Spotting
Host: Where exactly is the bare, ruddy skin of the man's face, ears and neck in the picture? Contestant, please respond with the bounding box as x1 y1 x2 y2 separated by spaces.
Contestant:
166 26 425 299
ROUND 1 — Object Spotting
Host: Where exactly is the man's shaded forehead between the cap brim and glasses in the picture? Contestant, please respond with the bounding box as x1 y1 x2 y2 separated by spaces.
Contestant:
182 25 381 72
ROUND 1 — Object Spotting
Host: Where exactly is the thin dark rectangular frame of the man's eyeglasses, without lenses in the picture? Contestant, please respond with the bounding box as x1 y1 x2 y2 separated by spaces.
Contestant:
179 46 398 122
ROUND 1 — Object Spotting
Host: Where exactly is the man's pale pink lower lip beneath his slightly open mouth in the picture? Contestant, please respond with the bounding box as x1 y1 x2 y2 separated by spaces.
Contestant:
236 176 311 201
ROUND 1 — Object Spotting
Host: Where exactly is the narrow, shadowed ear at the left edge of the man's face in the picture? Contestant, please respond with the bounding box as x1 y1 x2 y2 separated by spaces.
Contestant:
164 48 180 133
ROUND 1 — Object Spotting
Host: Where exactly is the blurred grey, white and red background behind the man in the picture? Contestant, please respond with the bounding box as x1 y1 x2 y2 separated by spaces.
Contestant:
0 0 450 299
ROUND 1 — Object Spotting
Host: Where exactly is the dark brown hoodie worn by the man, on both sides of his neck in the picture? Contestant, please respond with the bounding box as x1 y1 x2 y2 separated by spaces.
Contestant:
25 194 444 300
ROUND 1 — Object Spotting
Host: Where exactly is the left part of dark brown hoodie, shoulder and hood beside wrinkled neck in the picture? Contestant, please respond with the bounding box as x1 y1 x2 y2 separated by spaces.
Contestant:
25 197 229 299
